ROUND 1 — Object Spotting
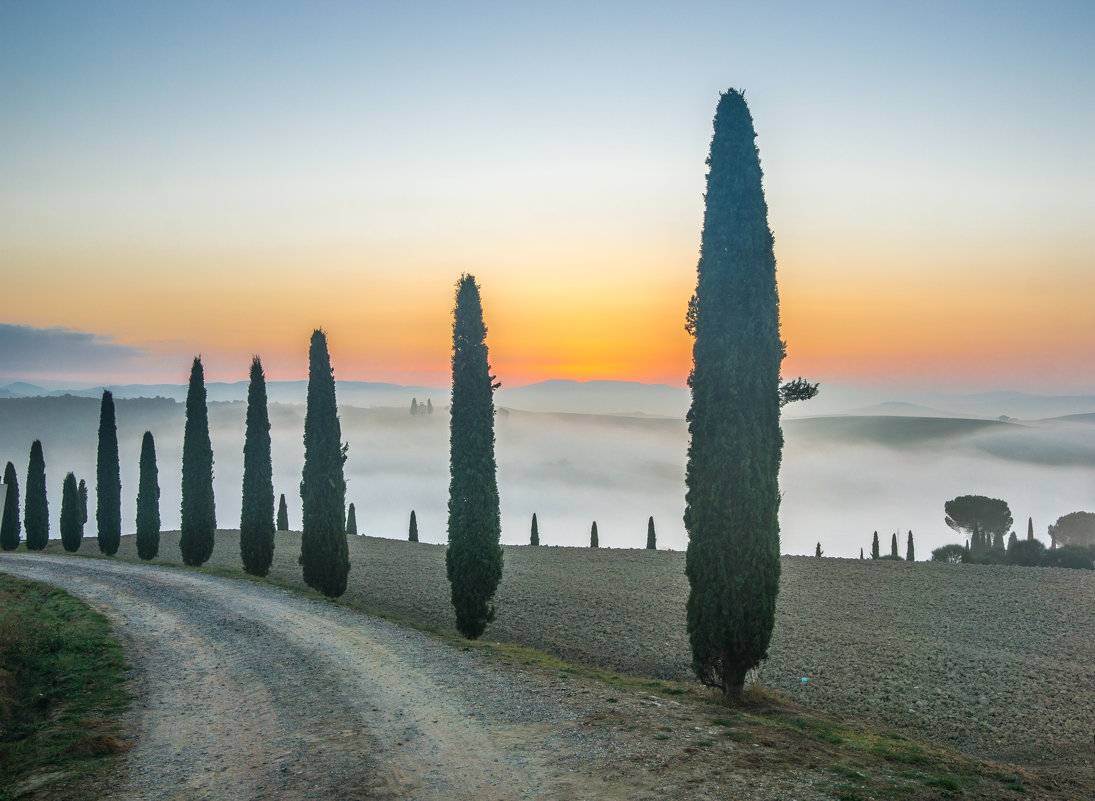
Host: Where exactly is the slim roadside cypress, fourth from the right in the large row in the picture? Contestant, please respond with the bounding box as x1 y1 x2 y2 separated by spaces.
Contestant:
240 356 275 576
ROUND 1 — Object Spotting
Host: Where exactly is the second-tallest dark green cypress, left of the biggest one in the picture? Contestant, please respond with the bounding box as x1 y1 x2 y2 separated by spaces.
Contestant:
445 275 502 639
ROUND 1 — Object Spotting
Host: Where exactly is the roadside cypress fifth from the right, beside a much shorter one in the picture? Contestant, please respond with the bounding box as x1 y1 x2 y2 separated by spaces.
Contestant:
178 356 217 566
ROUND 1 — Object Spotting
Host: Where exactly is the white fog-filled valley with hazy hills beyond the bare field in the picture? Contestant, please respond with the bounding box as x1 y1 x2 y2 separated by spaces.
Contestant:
0 397 1095 559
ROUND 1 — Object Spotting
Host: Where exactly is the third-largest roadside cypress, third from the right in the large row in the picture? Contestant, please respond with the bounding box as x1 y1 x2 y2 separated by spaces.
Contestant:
300 328 349 597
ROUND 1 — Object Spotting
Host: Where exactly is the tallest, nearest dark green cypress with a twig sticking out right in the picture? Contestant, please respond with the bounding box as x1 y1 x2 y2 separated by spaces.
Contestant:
684 90 783 697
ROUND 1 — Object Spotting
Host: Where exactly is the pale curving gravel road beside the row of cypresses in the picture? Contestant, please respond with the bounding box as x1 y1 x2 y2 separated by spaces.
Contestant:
0 554 831 801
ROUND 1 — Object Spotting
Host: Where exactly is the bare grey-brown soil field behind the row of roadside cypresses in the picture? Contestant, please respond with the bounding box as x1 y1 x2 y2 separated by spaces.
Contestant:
50 531 1095 781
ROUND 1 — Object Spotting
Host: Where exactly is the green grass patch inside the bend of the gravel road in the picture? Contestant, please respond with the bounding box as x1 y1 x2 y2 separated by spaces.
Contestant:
0 573 129 801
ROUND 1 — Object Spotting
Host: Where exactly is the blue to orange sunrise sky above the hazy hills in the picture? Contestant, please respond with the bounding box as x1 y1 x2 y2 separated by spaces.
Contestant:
0 0 1095 394
